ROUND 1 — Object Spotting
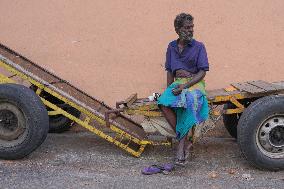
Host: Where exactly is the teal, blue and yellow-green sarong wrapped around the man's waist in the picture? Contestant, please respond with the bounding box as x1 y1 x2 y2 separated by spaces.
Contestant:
157 78 209 140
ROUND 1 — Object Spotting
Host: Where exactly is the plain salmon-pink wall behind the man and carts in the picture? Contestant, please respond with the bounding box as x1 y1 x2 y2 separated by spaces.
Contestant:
0 0 284 105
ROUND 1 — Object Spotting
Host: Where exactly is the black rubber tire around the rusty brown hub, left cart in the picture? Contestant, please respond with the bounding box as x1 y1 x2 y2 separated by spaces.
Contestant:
0 84 49 160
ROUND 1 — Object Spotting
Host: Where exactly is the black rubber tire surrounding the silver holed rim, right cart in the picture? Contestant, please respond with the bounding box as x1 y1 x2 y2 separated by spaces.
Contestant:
237 95 284 171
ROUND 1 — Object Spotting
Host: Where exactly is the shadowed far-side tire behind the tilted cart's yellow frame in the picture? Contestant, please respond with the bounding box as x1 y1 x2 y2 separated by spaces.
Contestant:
49 105 81 133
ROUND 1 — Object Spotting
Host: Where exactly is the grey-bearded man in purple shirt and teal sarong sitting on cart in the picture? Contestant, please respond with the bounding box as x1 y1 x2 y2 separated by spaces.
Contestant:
158 13 209 165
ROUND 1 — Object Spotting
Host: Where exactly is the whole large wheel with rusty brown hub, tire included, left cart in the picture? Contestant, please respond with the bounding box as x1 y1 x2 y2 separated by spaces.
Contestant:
0 84 49 159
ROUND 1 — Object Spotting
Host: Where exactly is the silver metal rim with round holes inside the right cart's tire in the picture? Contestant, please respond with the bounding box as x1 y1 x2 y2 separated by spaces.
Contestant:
257 116 284 158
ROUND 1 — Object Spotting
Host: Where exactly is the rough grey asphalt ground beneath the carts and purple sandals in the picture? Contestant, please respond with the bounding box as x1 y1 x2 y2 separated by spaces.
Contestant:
0 124 284 189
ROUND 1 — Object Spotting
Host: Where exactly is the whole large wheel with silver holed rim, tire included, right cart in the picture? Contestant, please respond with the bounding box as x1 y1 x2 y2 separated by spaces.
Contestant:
237 96 284 170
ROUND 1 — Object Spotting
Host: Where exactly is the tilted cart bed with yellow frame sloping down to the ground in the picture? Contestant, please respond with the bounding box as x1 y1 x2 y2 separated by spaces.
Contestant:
0 44 163 157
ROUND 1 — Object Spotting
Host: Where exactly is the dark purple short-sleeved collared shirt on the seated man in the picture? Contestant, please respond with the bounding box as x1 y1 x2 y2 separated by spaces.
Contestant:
165 39 209 75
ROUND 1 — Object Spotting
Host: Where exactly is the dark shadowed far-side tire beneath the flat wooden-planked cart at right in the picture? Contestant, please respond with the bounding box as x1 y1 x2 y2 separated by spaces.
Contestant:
223 103 241 139
